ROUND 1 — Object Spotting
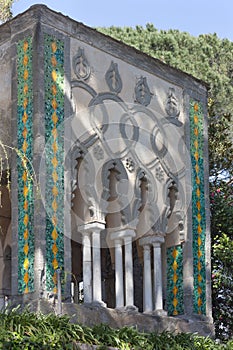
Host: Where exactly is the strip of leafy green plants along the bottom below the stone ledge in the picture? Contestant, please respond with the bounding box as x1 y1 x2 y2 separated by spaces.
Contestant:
0 309 233 350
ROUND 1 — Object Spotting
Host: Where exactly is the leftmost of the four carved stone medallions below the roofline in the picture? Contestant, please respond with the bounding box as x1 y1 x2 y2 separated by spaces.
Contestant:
73 47 91 80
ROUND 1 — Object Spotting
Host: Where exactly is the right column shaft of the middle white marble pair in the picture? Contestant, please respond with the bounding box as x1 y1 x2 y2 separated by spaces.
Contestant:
124 236 134 306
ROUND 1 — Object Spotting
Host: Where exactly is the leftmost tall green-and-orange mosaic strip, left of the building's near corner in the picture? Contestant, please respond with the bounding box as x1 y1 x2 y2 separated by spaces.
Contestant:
17 37 34 294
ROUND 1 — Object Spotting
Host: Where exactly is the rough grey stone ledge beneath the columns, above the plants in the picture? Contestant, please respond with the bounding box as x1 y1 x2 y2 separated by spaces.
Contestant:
12 299 215 338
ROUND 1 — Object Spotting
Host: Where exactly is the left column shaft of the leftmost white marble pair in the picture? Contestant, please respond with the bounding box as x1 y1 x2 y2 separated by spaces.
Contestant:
83 232 92 303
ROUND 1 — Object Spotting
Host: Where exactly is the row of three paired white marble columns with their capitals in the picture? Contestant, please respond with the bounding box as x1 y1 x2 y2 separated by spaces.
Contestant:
78 222 164 313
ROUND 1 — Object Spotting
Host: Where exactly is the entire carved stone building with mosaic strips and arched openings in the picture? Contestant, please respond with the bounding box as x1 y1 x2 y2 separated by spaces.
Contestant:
0 5 213 334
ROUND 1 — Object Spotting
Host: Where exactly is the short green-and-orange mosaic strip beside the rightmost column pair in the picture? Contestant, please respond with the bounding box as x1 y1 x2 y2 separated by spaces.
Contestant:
167 246 184 316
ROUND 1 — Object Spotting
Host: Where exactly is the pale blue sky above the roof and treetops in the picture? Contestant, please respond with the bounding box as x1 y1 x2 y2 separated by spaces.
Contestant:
13 0 233 41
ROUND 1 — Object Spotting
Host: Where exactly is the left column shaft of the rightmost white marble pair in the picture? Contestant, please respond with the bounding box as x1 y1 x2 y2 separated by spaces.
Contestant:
143 244 153 312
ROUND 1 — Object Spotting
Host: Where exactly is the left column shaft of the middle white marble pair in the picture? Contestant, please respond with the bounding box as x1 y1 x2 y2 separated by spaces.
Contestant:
114 239 124 308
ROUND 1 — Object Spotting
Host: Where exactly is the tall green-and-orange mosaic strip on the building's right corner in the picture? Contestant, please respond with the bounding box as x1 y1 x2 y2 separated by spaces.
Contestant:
190 101 206 315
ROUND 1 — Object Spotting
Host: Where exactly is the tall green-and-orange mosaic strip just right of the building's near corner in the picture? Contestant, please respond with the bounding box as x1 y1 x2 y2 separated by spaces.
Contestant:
44 35 64 293
